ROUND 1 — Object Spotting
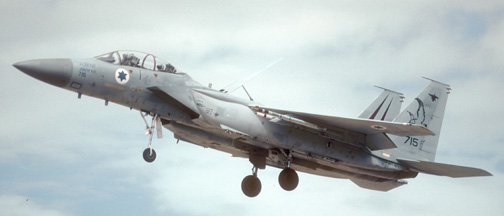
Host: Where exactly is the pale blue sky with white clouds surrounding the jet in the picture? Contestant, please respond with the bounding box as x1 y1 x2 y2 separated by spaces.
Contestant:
0 0 504 216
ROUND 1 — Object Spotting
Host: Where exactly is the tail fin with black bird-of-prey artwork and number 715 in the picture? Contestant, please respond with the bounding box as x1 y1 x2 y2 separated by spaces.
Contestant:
390 77 451 161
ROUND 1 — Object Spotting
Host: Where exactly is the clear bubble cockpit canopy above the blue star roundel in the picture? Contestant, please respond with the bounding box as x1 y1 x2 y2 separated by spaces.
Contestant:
95 50 177 73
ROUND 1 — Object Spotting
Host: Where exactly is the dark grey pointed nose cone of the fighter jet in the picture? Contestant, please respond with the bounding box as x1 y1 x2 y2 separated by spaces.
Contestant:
12 59 73 87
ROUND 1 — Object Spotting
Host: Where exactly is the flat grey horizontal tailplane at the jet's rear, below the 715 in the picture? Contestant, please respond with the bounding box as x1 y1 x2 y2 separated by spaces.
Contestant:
397 159 492 178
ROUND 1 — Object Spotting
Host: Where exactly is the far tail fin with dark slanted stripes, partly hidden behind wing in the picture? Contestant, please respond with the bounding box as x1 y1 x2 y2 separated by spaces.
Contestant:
359 86 404 121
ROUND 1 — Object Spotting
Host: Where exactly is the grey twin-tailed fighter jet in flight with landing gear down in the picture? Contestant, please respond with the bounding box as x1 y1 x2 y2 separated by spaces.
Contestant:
13 51 491 197
